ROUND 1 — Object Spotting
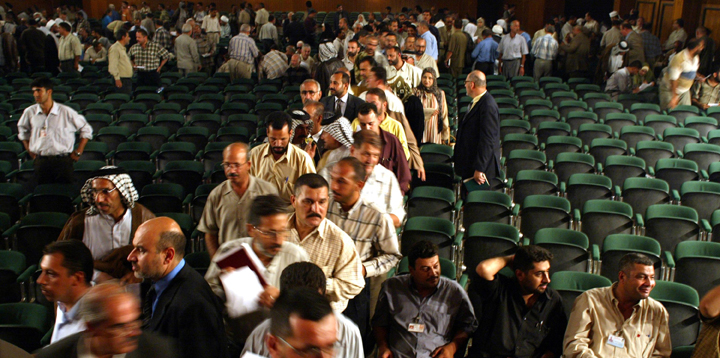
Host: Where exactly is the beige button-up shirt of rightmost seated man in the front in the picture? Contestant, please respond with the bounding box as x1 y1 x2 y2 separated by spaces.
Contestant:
563 282 672 358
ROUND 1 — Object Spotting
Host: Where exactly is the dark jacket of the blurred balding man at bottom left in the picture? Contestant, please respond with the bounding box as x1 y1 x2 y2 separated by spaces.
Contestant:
35 332 179 358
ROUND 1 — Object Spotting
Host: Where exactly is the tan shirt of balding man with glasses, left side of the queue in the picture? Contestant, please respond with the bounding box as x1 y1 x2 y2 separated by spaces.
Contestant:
197 175 277 245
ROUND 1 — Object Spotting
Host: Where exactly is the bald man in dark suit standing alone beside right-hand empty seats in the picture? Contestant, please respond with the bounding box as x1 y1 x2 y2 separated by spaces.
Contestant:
453 71 500 184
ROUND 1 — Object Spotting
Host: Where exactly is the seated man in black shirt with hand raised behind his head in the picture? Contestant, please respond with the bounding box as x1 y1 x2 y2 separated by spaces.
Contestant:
469 245 567 357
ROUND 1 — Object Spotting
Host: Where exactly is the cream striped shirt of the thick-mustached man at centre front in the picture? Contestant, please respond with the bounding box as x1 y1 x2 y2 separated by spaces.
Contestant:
288 214 365 312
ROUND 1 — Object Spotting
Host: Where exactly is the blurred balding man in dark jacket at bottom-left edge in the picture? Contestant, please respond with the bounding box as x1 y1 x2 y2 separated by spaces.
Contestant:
36 283 177 358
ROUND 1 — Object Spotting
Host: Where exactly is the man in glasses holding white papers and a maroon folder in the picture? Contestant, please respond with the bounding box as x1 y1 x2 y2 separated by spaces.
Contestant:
205 195 309 344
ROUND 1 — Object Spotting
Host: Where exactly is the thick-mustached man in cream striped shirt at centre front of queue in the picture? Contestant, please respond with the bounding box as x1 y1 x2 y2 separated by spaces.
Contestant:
289 173 365 312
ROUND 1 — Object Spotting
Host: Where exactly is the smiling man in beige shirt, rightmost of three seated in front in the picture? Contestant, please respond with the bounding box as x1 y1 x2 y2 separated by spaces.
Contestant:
563 253 672 358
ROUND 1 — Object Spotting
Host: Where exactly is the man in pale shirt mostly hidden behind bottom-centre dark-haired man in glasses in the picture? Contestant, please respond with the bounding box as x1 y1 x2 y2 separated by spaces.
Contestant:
243 262 365 358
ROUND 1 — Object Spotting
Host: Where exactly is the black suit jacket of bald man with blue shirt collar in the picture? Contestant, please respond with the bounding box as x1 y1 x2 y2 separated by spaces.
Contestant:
143 263 228 358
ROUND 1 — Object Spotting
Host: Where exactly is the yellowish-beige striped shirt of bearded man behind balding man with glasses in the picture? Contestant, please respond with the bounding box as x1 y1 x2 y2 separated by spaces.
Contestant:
250 143 315 203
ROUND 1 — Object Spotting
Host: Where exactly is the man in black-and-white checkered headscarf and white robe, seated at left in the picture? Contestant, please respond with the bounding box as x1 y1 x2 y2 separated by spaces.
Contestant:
58 166 155 283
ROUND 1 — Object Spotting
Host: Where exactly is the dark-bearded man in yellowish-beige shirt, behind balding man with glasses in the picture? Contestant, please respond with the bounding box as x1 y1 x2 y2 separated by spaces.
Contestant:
250 110 315 204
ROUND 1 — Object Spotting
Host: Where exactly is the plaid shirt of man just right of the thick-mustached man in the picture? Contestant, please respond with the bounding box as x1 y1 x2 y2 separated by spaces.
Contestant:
327 199 402 277
